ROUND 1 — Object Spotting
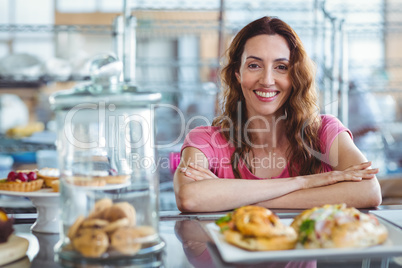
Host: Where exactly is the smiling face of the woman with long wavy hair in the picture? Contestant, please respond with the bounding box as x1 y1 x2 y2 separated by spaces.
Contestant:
236 34 292 117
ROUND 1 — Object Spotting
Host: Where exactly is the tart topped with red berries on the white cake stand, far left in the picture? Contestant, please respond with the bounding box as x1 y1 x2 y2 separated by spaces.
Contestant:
0 170 43 192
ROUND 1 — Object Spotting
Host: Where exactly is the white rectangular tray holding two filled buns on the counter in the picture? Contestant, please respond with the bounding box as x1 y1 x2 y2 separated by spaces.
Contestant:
206 218 402 263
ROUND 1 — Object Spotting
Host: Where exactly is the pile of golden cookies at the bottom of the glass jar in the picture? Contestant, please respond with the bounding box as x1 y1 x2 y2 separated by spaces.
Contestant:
67 198 157 258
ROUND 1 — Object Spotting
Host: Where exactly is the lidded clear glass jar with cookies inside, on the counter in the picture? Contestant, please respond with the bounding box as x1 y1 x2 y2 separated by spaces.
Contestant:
50 55 164 261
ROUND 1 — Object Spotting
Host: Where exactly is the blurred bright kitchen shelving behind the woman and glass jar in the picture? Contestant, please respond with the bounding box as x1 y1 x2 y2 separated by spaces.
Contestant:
0 0 402 207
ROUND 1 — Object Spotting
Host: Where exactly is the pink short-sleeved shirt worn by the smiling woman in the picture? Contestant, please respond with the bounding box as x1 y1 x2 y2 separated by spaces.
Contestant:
181 115 353 179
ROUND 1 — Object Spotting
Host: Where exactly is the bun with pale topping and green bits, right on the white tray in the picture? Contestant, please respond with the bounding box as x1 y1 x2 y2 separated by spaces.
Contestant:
291 204 388 249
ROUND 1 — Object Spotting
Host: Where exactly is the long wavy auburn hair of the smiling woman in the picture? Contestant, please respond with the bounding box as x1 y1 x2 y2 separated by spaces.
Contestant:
212 17 323 178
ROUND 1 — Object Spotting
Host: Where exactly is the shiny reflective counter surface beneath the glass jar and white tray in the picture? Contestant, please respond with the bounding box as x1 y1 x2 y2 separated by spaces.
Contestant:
5 205 402 268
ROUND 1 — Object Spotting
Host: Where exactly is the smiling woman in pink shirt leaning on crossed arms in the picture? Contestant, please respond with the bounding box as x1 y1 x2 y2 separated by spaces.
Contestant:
174 17 381 212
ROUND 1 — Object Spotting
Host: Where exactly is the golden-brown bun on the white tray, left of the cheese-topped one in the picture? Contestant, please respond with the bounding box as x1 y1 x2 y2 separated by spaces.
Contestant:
216 206 297 251
